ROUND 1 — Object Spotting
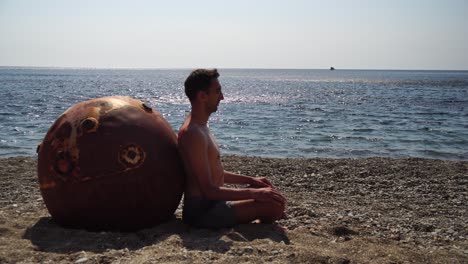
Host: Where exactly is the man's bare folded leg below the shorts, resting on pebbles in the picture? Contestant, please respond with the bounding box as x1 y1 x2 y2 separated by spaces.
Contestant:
231 200 285 224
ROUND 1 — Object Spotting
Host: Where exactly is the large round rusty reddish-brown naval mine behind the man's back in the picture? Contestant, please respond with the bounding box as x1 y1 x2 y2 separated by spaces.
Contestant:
37 96 184 230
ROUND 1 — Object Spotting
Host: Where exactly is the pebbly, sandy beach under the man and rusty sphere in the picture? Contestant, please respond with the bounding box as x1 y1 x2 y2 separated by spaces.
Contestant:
0 156 468 263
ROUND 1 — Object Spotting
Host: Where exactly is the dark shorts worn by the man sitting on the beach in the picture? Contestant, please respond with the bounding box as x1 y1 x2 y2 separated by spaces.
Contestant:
182 197 237 228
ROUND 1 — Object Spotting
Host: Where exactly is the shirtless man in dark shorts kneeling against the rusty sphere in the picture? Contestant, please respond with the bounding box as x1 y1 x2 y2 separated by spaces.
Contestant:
178 69 286 228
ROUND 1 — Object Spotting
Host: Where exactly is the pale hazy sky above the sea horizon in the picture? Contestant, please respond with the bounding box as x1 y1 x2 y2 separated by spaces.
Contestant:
0 0 468 70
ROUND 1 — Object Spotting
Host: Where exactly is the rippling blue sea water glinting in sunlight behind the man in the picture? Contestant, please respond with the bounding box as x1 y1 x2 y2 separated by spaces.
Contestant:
0 67 468 160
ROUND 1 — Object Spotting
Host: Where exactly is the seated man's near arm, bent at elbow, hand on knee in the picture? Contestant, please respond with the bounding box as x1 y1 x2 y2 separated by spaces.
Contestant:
179 129 286 204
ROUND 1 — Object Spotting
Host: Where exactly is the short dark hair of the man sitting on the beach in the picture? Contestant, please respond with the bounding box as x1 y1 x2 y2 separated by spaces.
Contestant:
184 69 219 101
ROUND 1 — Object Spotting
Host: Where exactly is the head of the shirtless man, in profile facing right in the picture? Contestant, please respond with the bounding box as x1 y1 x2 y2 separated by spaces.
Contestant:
184 69 224 112
